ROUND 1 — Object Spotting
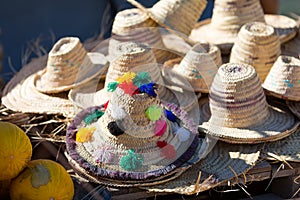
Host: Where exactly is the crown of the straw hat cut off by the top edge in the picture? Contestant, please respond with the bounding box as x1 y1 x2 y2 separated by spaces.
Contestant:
211 0 265 33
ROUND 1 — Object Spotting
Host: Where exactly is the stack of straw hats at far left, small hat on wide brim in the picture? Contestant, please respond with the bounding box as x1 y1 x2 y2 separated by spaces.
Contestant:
2 37 107 117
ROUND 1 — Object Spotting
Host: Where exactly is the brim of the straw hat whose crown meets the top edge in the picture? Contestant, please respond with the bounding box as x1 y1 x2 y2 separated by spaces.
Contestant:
190 14 299 54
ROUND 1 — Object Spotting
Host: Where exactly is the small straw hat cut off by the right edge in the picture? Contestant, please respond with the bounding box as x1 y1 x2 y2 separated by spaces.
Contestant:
263 56 300 101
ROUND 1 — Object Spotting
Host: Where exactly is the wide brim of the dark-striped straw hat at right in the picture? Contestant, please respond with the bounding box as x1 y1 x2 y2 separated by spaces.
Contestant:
199 99 299 144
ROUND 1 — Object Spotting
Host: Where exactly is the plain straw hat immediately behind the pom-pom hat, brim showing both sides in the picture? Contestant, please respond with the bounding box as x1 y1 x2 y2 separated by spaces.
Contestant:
69 42 197 111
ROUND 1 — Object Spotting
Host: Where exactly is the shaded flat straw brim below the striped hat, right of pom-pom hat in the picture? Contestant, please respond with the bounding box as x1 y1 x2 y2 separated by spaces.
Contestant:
143 141 260 195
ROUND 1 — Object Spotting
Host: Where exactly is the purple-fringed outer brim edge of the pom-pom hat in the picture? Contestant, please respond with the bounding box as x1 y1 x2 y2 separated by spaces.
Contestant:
66 106 204 187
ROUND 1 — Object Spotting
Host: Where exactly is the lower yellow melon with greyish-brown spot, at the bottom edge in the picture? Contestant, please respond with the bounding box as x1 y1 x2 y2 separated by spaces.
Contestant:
10 159 74 200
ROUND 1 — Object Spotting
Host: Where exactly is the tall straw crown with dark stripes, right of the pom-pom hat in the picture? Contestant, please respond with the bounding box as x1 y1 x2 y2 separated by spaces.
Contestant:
209 63 269 128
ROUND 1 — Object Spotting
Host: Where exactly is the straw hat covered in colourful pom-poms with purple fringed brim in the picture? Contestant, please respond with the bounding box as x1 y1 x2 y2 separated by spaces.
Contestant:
66 71 202 186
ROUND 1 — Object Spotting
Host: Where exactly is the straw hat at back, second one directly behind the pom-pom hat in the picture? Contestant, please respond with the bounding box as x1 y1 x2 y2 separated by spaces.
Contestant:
108 8 180 63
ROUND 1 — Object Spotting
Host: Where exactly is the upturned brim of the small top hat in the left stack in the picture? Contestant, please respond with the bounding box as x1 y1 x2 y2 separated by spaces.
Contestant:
34 52 108 94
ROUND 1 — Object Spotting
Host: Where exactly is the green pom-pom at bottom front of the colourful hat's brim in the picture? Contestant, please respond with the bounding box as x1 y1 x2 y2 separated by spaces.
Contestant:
120 149 144 171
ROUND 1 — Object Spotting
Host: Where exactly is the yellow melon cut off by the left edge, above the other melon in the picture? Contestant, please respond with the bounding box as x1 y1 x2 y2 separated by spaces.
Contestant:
0 122 32 180
